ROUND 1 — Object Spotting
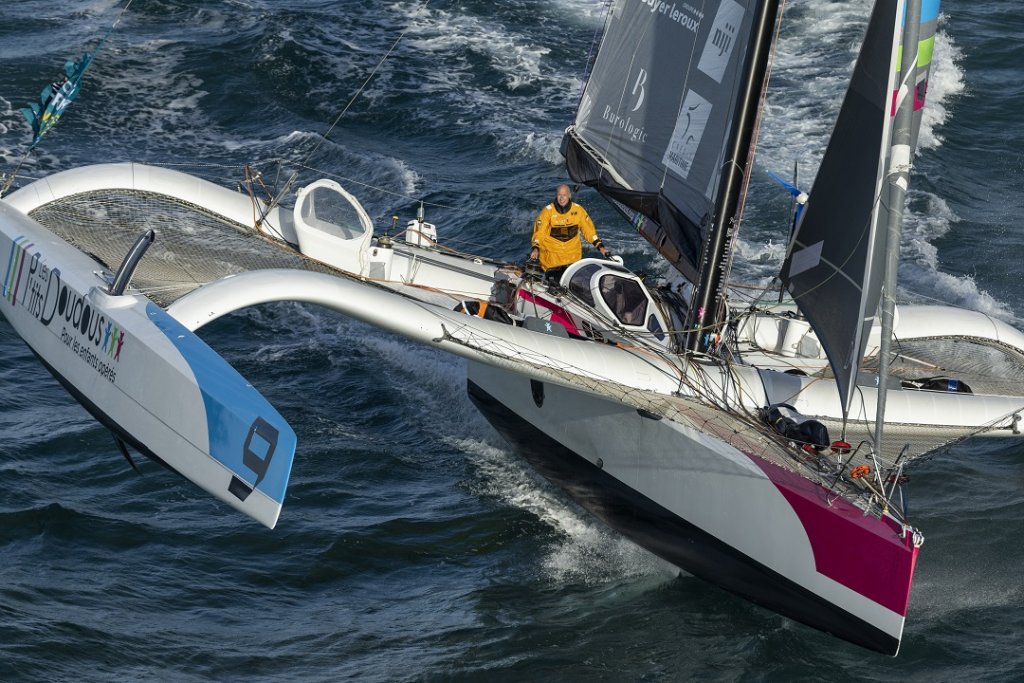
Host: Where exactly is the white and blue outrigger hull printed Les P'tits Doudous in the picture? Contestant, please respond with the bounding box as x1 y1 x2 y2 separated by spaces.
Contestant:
0 203 296 527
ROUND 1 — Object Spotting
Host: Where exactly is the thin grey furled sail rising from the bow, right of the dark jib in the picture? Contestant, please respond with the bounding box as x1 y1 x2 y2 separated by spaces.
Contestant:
874 0 921 453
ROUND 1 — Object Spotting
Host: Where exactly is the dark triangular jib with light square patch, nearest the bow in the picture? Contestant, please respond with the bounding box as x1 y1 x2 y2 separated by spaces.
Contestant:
781 0 939 414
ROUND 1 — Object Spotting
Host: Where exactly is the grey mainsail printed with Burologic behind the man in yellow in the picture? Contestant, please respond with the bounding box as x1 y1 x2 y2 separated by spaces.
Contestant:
563 0 777 283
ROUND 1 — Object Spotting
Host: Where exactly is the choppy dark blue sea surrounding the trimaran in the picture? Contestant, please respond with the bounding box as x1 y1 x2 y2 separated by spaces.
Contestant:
0 0 1024 681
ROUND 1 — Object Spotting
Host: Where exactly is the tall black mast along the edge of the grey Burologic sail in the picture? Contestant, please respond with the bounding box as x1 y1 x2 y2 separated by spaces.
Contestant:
686 0 779 351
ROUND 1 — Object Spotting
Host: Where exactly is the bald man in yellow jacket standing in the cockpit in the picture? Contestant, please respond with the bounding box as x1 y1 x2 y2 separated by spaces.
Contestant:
529 185 611 282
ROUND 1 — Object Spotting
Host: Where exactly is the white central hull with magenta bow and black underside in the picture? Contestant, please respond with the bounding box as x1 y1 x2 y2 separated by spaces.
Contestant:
468 362 918 654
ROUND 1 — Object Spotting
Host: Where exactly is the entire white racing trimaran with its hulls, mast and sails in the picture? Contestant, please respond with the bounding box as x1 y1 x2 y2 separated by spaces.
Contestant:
0 0 1024 654
